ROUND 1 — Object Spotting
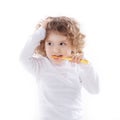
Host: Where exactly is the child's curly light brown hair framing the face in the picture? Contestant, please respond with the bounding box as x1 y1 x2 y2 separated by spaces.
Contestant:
35 16 85 56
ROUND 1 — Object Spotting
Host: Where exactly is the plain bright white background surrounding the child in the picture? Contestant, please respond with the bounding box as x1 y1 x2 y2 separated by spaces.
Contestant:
0 0 120 120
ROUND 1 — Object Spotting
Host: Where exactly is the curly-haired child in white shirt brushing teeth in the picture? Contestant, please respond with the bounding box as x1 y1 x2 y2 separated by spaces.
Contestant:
21 16 99 120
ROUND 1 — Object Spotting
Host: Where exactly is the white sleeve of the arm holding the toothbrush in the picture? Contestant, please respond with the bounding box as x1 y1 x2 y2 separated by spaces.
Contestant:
79 64 99 94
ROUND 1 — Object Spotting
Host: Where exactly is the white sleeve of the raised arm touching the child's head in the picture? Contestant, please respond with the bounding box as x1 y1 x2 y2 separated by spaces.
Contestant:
20 27 46 74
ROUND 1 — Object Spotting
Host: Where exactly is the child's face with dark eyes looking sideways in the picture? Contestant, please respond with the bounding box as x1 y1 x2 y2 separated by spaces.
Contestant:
45 32 72 64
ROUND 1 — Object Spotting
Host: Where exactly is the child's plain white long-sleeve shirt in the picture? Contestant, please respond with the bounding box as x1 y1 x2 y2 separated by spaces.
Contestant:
20 28 99 120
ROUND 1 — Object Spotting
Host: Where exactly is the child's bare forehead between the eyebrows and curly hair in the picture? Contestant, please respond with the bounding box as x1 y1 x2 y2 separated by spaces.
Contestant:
46 32 70 42
